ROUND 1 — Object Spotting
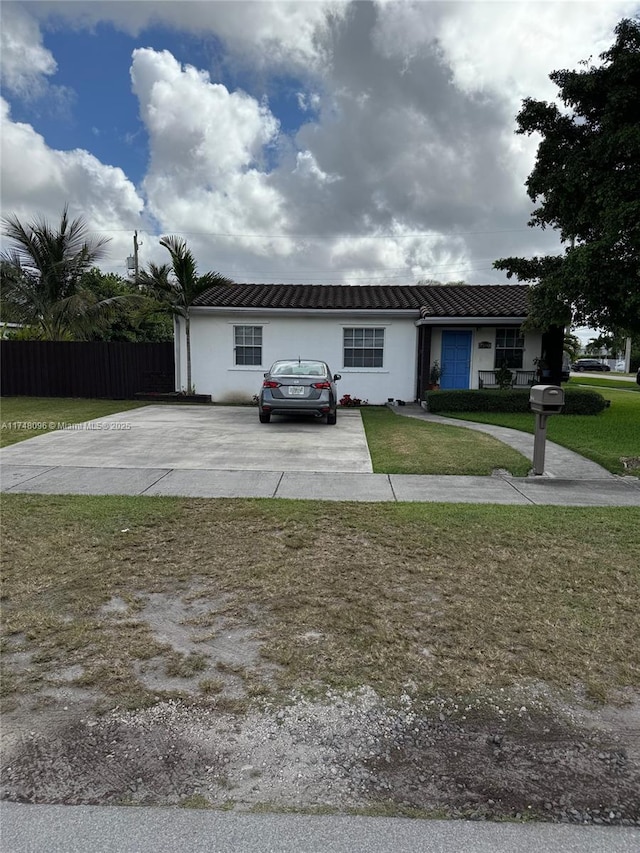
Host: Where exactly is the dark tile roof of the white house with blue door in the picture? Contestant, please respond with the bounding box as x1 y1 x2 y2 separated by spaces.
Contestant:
193 284 528 318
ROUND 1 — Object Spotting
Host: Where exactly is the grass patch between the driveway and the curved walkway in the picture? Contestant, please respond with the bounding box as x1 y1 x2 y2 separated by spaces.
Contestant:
360 406 531 477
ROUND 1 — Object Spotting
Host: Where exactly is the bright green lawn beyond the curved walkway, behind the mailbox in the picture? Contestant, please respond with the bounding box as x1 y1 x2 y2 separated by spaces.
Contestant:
443 379 640 475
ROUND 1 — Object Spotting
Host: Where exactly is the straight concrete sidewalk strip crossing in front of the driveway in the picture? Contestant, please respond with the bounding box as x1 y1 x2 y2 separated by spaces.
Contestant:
1 464 640 506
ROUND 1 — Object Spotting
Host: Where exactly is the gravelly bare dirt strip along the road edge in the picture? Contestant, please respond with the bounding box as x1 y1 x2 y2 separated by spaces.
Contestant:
2 688 640 825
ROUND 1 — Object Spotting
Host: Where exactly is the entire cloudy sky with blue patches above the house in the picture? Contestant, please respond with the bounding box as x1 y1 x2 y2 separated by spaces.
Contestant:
0 0 640 310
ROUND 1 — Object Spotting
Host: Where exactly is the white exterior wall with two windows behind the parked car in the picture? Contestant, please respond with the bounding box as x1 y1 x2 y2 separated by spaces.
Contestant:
176 310 417 405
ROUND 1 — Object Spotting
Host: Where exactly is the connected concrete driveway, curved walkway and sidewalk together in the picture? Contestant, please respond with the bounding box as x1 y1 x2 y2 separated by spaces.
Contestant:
0 405 640 506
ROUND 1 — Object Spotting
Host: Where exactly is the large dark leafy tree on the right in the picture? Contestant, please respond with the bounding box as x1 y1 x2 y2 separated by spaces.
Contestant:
494 19 640 332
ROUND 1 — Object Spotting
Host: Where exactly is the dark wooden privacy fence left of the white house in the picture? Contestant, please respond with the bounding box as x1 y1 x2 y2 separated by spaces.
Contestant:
0 341 175 400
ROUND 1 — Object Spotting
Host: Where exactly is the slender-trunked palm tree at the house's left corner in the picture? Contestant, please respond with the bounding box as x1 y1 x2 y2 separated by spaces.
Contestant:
138 236 233 394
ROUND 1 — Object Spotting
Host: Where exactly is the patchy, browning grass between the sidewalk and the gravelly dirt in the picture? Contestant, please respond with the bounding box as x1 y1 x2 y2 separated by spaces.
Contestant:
2 495 640 707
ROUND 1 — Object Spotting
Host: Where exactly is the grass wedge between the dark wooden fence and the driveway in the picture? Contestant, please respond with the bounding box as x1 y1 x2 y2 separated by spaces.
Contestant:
0 397 147 447
